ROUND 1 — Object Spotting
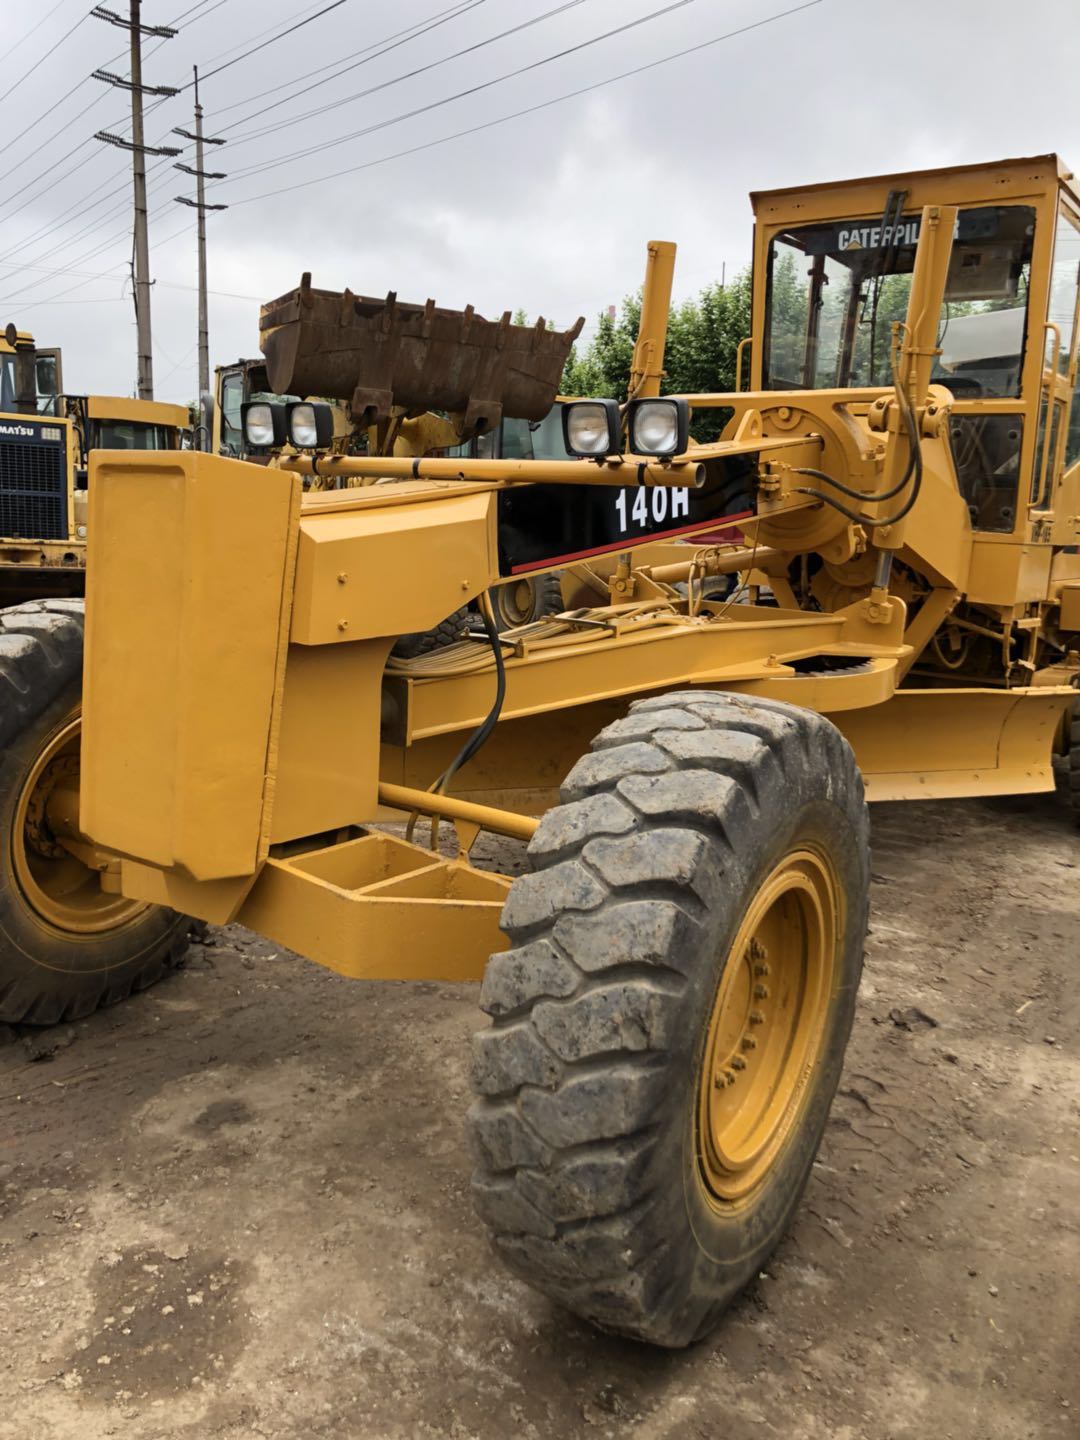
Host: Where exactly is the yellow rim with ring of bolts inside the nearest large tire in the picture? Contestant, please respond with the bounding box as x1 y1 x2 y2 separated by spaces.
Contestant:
697 850 837 1204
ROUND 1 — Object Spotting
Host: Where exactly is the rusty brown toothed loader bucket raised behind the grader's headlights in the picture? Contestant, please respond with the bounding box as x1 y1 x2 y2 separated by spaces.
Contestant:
259 275 585 438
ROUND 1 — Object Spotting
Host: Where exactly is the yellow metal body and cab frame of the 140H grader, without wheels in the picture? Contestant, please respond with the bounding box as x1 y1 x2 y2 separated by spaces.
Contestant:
79 157 1080 978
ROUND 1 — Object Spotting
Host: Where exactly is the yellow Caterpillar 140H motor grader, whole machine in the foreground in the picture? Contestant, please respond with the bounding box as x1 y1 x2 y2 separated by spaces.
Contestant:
0 156 1080 1346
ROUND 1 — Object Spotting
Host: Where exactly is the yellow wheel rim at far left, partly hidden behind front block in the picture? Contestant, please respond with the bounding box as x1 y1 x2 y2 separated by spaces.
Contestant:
12 714 147 939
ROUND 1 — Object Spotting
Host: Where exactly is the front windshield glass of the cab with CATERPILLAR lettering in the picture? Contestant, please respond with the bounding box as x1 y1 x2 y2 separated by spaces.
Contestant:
765 204 1035 399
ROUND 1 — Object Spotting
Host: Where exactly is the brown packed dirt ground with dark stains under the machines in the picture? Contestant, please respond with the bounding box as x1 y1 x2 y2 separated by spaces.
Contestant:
0 796 1080 1440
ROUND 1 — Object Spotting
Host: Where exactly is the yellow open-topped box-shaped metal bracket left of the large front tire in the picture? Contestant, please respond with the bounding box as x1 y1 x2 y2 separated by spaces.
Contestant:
238 832 510 981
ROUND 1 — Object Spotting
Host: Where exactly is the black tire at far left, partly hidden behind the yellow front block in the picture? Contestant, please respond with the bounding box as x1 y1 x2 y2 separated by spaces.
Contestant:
0 599 190 1025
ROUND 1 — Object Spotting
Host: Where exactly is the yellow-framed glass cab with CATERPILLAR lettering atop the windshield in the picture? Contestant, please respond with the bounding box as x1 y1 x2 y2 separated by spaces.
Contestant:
752 156 1080 540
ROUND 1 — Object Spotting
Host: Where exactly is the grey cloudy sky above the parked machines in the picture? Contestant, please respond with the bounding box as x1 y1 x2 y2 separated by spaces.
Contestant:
0 0 1080 402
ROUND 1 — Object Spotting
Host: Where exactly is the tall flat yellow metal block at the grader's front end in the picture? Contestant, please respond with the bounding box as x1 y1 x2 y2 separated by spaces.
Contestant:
82 451 300 880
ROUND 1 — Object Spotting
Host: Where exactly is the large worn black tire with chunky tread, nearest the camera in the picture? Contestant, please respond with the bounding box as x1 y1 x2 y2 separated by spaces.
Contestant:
469 691 870 1346
